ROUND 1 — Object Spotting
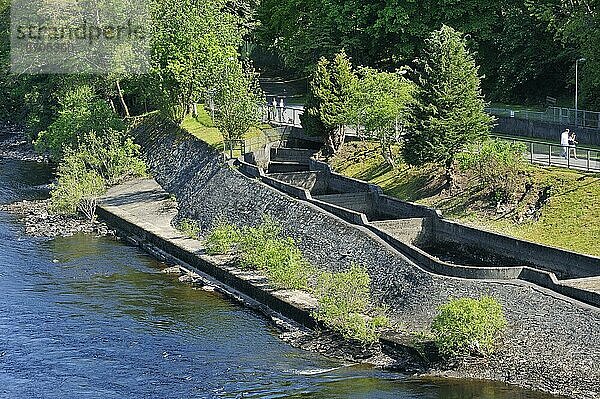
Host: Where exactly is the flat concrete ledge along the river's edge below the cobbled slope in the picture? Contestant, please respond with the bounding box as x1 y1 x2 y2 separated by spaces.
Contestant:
98 179 398 369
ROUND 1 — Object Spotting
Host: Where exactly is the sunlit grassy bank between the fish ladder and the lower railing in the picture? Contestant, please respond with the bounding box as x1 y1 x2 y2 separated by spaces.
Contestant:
331 142 600 256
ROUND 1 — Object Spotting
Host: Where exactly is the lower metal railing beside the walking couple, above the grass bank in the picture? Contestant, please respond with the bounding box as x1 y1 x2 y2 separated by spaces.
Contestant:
494 136 600 172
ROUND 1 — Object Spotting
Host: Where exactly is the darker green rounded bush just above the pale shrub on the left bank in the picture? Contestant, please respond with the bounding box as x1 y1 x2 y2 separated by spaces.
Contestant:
35 85 124 161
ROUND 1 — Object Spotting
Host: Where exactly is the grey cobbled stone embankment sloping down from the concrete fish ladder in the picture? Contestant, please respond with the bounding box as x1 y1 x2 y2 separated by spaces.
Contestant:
127 114 600 398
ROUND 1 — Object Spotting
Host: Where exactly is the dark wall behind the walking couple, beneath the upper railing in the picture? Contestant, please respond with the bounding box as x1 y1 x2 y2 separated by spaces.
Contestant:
493 116 600 146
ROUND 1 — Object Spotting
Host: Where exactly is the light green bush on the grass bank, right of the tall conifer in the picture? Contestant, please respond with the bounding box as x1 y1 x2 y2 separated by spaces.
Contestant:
458 140 527 203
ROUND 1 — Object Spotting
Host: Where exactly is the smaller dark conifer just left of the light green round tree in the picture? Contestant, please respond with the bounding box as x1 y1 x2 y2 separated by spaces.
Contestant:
301 52 356 153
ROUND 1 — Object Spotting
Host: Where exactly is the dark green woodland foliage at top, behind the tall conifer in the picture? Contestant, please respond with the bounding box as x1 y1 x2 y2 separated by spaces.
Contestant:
257 0 568 101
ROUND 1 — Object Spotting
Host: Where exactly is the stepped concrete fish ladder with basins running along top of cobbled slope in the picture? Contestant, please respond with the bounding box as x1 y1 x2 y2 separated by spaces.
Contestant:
235 155 600 307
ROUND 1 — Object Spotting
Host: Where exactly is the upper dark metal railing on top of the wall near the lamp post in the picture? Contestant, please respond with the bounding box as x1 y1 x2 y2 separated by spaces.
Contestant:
486 107 600 129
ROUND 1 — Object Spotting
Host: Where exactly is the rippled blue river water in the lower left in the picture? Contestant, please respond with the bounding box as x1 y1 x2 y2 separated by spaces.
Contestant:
0 159 550 399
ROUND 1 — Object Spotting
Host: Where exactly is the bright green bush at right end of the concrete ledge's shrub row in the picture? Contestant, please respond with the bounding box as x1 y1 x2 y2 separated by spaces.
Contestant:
314 265 389 343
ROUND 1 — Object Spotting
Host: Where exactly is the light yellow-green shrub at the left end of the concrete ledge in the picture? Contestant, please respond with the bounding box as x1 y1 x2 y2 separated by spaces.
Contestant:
50 149 105 220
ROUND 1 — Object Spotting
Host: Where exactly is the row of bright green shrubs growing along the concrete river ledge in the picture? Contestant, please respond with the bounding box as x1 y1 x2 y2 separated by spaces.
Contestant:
205 217 389 344
